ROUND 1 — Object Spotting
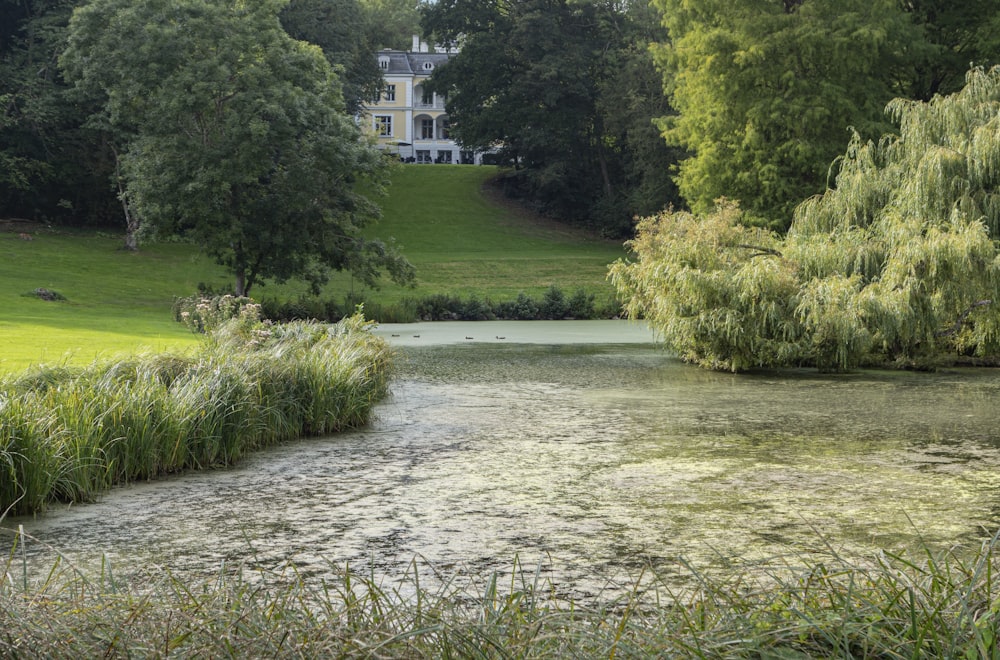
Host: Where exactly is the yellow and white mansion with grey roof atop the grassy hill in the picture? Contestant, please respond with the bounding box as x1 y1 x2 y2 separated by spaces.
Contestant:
361 36 482 164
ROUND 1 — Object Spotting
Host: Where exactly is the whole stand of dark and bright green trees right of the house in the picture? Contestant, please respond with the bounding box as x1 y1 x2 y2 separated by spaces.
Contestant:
423 0 1000 234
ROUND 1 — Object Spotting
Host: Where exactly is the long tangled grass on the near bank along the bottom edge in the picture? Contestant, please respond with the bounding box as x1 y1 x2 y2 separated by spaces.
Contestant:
0 537 1000 659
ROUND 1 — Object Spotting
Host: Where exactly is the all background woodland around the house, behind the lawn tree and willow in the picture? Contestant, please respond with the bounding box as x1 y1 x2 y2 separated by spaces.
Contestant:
0 0 1000 237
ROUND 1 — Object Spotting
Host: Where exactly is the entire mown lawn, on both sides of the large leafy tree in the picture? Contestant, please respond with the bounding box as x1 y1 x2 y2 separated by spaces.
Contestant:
0 165 624 372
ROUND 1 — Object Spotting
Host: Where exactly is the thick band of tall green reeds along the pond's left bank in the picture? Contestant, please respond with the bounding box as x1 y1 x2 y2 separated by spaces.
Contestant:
0 304 391 519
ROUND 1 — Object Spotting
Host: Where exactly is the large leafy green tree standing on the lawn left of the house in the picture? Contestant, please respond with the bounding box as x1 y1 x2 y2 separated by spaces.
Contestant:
62 0 412 295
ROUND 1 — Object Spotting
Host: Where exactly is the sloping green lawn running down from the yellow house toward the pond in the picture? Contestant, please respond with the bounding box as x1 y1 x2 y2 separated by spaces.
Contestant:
266 165 624 303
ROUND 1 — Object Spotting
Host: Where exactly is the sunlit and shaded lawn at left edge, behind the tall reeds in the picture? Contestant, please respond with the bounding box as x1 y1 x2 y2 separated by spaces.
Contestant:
0 231 217 371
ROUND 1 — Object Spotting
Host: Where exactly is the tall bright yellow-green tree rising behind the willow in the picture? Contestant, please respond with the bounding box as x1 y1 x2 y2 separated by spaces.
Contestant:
653 0 929 229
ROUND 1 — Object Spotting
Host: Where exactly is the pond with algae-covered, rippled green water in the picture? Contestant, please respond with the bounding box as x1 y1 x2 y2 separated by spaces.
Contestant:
2 321 1000 596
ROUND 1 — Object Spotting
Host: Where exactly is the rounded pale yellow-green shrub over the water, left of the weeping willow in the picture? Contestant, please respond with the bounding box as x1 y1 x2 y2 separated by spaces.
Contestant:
610 202 802 371
